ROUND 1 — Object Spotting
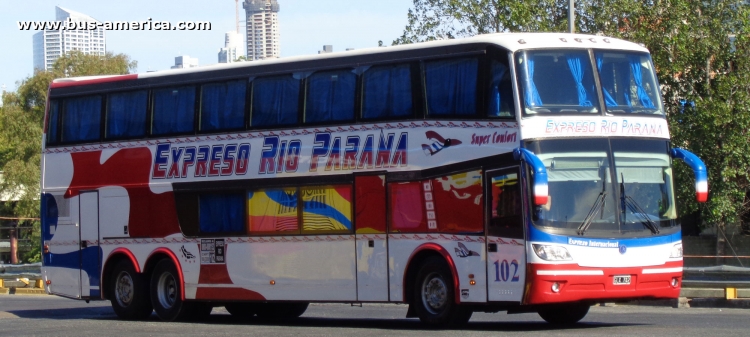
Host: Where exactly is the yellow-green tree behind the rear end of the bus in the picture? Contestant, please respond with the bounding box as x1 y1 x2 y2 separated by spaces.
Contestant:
0 51 137 261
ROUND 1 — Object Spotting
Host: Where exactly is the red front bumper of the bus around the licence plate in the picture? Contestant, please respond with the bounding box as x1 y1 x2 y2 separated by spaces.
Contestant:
524 261 682 304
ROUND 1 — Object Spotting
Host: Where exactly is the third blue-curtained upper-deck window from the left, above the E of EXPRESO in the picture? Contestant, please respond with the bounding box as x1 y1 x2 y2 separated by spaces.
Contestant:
151 86 195 135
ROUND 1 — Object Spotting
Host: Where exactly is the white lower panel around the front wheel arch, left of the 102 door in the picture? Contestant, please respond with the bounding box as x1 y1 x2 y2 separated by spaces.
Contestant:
388 233 487 303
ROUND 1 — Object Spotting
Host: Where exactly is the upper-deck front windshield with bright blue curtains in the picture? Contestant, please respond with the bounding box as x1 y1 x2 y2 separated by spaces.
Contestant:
516 50 663 116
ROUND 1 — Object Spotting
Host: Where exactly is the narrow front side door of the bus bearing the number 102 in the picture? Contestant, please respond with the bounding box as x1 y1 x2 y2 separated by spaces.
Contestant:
485 166 526 302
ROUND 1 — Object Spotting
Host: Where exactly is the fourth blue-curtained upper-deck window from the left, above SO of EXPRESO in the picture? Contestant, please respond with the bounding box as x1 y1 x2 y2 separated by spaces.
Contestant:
200 80 247 131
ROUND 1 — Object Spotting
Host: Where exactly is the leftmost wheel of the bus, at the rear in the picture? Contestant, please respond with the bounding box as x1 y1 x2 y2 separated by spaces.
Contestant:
109 260 154 320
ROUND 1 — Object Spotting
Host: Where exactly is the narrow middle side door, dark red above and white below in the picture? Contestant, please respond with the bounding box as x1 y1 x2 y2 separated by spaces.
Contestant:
354 175 388 302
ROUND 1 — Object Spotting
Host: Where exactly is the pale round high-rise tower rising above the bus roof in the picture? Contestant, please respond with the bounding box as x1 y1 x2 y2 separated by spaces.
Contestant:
242 0 281 60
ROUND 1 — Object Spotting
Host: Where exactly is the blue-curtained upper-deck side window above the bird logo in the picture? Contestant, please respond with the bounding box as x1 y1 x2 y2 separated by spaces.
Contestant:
425 58 479 116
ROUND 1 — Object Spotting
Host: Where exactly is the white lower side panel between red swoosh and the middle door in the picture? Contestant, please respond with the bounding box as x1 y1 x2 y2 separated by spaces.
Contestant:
220 235 357 301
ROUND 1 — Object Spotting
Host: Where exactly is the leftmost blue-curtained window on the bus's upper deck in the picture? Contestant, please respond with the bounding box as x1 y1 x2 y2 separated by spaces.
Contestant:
62 96 102 142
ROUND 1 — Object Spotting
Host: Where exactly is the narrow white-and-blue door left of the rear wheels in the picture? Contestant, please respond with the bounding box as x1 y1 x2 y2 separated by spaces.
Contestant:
78 191 101 298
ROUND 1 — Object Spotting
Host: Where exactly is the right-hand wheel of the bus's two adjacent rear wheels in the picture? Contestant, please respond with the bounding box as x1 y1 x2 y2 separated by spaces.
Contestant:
151 259 195 322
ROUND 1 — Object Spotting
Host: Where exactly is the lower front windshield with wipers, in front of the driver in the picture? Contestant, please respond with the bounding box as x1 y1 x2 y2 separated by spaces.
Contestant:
527 139 677 237
